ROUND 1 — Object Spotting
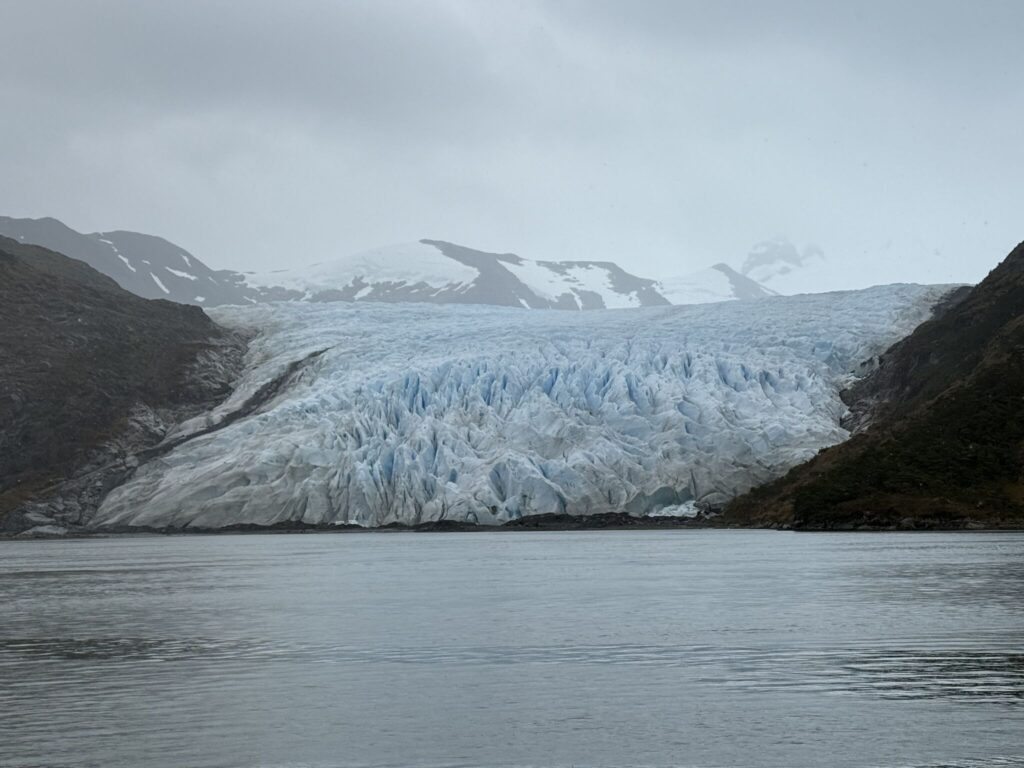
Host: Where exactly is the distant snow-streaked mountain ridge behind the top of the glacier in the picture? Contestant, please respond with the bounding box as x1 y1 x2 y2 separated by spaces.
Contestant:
0 217 771 309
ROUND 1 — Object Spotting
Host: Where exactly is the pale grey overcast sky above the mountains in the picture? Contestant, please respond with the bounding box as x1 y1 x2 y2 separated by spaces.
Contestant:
0 0 1024 287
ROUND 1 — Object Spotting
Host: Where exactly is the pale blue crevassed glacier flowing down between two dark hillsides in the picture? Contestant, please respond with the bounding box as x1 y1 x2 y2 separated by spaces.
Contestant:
93 285 945 526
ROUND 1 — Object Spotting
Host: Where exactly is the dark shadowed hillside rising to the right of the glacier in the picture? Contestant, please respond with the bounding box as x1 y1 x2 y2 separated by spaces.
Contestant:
722 244 1024 529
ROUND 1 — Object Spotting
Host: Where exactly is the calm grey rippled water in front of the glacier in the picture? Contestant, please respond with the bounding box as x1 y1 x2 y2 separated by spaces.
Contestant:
0 530 1024 768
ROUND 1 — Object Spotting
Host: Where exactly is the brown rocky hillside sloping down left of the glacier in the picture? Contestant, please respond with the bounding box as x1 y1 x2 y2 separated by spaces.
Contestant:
0 238 244 530
